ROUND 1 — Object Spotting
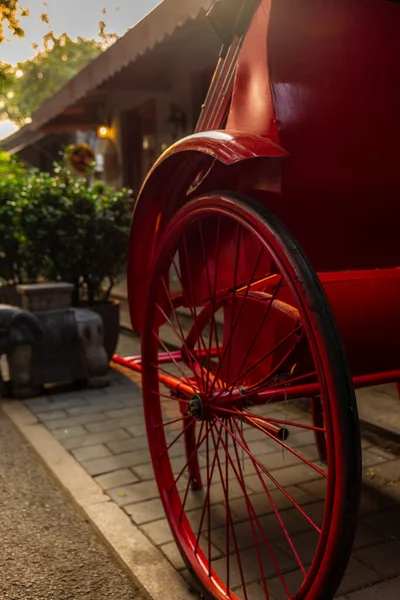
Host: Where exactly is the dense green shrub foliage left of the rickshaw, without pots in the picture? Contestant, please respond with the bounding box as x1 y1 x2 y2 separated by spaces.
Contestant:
0 159 132 304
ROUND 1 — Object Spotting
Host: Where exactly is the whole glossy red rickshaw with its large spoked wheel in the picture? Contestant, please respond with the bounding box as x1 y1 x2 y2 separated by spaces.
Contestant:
115 0 400 600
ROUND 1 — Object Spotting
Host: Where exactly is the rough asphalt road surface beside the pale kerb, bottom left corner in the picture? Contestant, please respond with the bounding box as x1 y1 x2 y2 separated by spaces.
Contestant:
0 406 144 600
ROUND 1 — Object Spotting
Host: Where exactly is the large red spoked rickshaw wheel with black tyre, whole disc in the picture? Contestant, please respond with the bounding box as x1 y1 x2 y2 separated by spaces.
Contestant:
142 192 361 600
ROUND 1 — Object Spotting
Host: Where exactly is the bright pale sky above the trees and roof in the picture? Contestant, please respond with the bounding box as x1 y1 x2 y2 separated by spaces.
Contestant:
0 0 162 139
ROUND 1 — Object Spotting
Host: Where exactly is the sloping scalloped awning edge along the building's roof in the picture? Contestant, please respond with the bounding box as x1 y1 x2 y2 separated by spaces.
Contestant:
31 0 213 131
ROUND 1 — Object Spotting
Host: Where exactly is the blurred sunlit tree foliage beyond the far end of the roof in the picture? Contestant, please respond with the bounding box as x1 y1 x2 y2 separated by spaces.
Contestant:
0 32 106 125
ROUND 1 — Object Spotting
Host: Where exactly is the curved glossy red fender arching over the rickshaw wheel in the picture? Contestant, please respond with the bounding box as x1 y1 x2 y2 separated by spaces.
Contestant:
127 131 288 332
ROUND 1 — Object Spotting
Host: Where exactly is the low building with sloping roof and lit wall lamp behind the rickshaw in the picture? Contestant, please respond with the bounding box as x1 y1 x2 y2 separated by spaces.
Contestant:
3 0 220 193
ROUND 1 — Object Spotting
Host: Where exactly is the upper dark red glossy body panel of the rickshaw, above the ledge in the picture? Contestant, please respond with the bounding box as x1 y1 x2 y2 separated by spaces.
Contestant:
227 0 400 271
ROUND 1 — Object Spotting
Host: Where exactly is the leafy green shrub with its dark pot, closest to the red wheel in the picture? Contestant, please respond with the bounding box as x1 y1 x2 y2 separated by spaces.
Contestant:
41 166 132 358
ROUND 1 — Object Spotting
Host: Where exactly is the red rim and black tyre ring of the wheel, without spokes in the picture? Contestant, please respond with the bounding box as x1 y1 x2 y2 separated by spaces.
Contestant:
139 194 360 600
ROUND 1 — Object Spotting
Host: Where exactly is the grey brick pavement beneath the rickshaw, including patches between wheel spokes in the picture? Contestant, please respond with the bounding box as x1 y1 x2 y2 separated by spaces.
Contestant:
20 338 400 600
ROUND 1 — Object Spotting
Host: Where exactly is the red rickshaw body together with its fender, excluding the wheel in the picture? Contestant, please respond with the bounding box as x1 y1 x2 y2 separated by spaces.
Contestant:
128 0 400 375
